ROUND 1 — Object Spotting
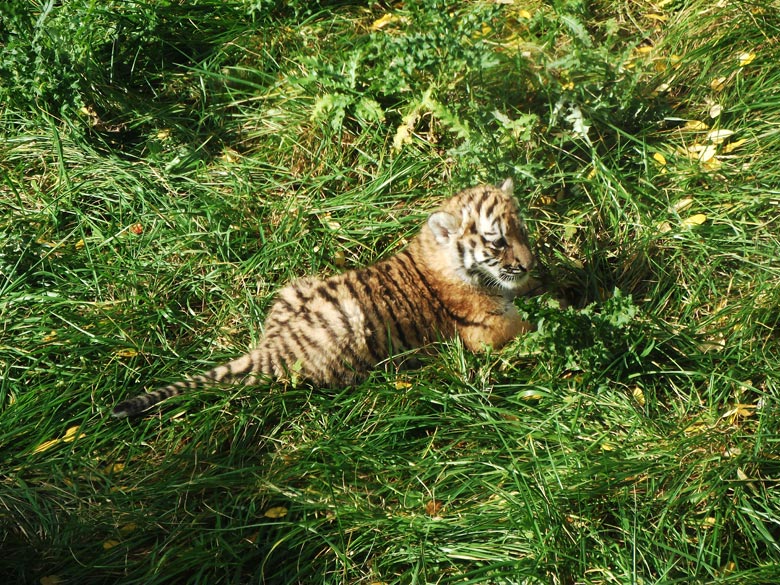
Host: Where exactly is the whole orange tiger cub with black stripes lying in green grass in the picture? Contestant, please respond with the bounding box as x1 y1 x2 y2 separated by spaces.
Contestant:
113 179 535 418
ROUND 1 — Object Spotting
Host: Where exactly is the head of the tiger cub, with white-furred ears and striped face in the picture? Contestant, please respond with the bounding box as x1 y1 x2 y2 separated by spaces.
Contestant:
428 179 536 293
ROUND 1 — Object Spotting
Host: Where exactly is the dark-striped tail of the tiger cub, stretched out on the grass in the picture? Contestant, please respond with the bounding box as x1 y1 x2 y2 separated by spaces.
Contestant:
111 348 271 418
